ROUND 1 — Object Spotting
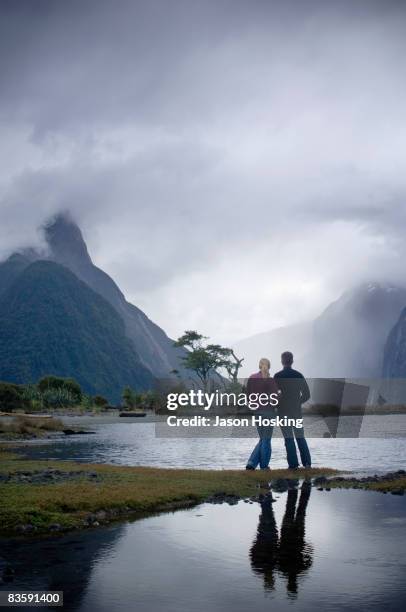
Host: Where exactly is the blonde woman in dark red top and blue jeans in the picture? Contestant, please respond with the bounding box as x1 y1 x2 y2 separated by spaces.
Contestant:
245 357 279 470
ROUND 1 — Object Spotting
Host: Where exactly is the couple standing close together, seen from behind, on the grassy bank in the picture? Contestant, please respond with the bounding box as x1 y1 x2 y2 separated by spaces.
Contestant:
246 351 312 470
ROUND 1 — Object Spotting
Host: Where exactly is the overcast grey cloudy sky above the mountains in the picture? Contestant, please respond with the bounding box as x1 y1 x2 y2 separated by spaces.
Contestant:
0 0 406 342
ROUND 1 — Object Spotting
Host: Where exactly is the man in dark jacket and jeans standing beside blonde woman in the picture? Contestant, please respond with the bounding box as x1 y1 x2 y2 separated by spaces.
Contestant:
274 351 312 470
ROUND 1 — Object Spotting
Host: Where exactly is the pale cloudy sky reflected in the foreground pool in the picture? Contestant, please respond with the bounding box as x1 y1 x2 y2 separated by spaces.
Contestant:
70 489 406 611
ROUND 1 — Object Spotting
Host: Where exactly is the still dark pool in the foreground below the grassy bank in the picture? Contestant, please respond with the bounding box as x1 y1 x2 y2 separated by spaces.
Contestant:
0 484 406 612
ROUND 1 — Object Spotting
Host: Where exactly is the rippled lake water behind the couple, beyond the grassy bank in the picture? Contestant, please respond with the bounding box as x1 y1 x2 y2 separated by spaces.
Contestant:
15 415 406 472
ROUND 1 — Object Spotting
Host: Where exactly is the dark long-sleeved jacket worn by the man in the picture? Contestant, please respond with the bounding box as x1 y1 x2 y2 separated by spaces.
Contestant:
274 366 310 418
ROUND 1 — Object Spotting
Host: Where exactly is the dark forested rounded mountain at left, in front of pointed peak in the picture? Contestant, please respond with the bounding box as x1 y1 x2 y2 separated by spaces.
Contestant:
0 256 154 401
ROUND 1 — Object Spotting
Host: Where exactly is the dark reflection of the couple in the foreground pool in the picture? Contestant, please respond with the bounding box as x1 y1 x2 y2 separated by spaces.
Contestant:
250 481 313 595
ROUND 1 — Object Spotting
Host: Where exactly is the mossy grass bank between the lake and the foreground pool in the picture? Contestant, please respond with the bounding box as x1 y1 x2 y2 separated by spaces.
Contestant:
0 448 406 535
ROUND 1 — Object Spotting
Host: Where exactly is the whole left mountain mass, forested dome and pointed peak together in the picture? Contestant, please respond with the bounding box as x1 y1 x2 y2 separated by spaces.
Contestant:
0 214 184 400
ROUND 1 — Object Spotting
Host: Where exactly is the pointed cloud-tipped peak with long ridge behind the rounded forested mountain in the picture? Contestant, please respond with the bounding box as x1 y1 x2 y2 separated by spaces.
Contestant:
45 214 185 378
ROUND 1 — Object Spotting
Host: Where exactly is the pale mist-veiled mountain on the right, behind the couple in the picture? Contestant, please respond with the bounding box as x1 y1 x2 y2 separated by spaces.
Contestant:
235 283 406 378
